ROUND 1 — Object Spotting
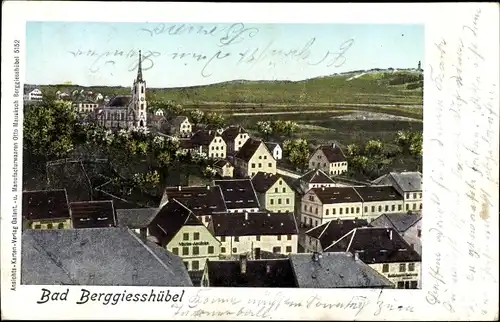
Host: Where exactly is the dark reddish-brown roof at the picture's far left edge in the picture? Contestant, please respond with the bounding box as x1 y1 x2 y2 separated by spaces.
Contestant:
22 189 70 220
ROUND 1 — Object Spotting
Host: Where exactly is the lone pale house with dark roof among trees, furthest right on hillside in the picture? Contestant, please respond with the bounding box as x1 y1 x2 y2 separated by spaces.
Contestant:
309 143 347 175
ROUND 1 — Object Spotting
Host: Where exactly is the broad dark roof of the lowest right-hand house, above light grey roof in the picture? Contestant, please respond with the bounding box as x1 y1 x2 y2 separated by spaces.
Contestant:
324 227 421 264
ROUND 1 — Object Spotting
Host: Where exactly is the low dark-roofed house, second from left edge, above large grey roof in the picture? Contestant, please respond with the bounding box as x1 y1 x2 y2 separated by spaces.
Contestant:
69 200 116 228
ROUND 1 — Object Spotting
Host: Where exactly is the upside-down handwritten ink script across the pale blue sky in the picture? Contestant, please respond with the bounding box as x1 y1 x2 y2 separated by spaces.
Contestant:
68 23 354 77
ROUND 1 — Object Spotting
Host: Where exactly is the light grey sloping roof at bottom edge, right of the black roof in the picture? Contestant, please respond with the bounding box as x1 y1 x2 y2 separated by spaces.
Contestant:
290 253 394 288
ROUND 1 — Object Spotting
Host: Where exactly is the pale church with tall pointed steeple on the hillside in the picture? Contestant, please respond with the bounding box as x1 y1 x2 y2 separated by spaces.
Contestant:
97 50 147 129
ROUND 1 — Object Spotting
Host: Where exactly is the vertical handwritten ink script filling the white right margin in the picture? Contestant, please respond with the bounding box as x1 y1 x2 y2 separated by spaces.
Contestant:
426 8 498 316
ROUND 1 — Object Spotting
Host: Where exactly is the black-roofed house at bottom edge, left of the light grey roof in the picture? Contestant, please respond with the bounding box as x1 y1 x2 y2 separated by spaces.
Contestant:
201 255 296 288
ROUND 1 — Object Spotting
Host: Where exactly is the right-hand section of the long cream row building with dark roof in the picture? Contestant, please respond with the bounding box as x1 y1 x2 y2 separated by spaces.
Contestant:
354 186 404 221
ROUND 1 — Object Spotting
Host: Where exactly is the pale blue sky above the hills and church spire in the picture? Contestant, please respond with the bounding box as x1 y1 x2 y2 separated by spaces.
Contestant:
25 21 425 88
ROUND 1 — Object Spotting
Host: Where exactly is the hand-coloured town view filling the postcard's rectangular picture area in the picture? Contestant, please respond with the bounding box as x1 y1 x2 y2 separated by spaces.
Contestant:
20 21 425 290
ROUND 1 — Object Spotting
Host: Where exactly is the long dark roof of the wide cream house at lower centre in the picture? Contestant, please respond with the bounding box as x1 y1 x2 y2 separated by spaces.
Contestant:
210 212 299 236
